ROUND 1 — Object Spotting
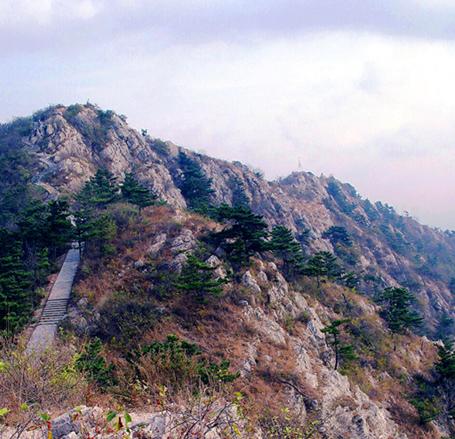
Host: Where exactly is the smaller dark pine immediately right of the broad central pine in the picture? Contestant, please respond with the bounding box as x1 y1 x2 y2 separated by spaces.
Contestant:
269 225 304 276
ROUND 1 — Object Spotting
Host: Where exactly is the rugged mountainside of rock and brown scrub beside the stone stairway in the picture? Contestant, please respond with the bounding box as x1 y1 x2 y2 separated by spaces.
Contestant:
0 104 455 439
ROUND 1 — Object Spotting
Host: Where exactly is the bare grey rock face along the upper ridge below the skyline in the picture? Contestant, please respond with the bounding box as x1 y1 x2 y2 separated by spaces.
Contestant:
8 104 455 336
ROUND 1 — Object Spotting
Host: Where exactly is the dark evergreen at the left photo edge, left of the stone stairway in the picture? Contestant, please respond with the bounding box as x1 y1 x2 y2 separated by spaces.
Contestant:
0 241 32 334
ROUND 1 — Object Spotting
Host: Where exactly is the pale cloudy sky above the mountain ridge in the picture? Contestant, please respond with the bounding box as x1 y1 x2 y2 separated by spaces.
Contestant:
0 0 455 229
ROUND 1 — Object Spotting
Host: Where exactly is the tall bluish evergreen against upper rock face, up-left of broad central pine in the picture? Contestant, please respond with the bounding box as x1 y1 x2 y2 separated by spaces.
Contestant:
178 152 213 213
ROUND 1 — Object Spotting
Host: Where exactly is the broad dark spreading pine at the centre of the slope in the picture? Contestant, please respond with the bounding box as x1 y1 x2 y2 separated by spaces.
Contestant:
212 204 268 268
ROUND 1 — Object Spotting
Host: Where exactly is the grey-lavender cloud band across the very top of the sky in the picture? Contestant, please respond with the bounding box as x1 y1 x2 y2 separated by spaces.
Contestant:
0 0 455 55
